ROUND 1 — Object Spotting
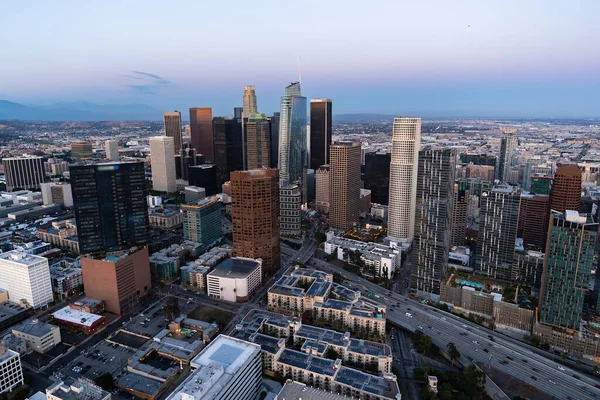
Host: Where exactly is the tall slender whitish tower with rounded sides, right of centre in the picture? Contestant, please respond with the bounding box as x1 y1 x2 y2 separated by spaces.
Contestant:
388 118 421 242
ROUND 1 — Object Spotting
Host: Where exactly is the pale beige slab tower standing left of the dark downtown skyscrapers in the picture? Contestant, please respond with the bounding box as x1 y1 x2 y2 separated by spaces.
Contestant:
150 136 177 193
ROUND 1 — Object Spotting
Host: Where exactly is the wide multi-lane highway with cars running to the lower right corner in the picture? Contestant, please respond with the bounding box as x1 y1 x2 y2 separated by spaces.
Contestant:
309 258 600 400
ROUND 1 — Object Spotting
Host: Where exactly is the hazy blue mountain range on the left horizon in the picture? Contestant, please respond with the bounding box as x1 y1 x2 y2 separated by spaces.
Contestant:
0 100 162 121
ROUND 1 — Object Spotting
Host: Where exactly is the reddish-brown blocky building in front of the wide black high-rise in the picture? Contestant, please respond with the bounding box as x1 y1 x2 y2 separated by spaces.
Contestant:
81 247 152 315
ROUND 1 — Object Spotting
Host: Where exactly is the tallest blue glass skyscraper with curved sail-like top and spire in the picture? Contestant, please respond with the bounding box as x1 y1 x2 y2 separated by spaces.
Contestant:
279 82 307 183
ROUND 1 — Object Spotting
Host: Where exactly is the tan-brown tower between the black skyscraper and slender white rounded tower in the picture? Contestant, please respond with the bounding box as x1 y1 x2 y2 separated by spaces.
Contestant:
329 142 360 231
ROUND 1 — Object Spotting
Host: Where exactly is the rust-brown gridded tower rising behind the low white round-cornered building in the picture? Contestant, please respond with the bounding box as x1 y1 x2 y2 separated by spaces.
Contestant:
231 168 280 275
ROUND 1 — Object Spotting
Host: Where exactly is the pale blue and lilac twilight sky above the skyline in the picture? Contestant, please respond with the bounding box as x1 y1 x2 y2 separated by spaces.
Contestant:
0 0 600 118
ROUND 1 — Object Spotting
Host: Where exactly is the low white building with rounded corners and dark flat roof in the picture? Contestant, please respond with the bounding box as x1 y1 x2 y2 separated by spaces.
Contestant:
206 257 262 303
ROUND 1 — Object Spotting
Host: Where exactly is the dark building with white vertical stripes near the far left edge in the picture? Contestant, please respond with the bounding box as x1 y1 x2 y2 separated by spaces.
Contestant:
2 156 45 192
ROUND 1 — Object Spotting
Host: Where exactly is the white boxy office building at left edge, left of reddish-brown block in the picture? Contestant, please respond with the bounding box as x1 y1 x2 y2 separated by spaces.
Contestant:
0 250 54 308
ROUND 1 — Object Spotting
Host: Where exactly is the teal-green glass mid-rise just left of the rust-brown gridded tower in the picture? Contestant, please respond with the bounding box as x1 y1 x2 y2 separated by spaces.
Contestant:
181 197 223 251
